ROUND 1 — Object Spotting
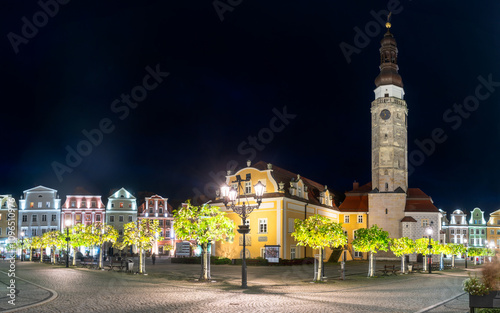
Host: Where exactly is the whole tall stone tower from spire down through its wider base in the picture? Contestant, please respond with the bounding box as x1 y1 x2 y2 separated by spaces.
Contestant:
368 23 408 241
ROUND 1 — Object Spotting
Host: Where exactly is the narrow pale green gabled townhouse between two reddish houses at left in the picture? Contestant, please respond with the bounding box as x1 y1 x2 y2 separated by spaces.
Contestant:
106 188 137 236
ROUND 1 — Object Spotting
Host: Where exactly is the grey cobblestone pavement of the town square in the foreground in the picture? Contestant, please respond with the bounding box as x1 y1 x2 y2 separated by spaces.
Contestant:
0 259 477 313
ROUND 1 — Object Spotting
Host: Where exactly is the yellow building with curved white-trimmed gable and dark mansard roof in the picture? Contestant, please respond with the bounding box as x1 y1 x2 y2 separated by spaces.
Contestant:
212 162 340 260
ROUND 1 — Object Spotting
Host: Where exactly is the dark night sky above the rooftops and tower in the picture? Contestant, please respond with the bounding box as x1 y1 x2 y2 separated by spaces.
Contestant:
0 0 500 212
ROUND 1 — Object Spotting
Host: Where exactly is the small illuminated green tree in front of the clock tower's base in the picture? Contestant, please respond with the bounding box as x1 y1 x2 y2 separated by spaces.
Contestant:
352 225 389 277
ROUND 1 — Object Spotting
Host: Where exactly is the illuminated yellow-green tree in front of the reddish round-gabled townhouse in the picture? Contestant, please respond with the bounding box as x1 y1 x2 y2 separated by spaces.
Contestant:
123 219 163 274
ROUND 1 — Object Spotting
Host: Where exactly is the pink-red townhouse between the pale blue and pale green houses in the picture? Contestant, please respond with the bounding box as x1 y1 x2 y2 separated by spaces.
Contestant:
61 188 106 231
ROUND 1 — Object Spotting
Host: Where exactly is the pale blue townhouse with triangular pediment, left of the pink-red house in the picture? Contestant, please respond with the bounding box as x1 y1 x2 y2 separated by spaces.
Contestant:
18 186 61 237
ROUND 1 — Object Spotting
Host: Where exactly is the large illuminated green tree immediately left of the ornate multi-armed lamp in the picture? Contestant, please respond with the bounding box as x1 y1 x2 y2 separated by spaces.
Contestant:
174 201 236 280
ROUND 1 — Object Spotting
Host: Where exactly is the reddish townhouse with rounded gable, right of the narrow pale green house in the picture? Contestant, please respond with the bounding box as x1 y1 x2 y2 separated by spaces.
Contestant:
137 195 175 254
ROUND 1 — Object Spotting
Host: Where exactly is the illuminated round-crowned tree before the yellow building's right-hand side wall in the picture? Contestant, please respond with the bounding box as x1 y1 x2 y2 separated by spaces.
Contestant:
292 214 347 281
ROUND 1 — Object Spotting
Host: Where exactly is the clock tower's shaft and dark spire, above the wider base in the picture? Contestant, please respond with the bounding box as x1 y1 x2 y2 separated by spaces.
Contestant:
371 22 408 193
